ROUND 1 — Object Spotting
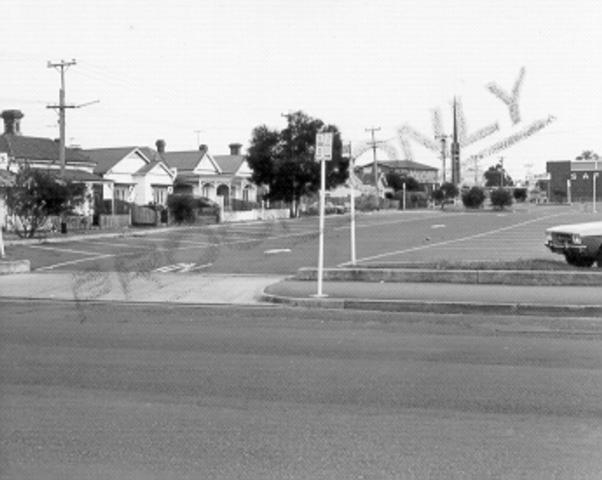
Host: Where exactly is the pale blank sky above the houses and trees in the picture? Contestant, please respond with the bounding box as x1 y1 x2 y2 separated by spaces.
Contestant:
0 0 602 179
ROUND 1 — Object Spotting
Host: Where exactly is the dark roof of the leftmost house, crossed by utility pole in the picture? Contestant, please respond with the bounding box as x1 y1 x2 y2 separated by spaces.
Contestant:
0 134 92 163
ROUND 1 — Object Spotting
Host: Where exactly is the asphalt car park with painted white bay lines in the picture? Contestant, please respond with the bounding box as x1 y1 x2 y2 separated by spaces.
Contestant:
12 206 602 274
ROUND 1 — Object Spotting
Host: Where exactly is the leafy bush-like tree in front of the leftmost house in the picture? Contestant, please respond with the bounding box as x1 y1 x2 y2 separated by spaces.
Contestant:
6 166 86 238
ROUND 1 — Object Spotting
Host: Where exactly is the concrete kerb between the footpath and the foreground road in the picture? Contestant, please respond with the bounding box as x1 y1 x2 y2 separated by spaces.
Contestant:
262 293 602 318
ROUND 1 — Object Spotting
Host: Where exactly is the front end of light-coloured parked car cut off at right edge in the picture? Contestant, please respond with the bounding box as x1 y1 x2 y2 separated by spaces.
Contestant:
545 222 602 268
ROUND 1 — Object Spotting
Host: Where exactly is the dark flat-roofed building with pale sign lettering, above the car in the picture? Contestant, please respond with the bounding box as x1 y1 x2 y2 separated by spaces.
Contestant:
546 159 602 202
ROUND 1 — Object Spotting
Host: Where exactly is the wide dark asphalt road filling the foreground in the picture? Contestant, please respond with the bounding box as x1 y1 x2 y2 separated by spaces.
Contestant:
0 301 602 480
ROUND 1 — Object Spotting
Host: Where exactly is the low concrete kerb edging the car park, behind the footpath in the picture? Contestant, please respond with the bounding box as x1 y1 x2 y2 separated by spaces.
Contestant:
295 267 602 286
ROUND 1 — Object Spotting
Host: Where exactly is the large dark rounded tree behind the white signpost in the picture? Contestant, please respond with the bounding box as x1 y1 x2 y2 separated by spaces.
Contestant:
247 111 349 212
